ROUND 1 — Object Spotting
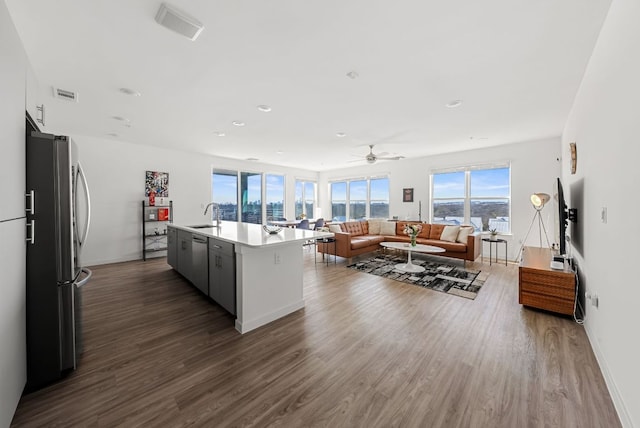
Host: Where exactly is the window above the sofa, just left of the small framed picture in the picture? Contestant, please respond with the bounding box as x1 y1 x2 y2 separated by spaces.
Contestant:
330 177 389 221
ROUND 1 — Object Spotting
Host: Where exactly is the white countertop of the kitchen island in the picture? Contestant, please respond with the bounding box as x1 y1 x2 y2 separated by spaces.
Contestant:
167 221 333 247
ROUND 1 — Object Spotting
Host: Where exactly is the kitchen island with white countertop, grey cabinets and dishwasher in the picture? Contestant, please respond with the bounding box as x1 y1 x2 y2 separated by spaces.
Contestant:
167 221 333 333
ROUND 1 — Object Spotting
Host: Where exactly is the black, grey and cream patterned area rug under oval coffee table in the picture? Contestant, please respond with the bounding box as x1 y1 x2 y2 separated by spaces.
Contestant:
347 253 489 299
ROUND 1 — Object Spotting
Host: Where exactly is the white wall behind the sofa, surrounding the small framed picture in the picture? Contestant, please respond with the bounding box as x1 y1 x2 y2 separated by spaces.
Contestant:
319 137 560 260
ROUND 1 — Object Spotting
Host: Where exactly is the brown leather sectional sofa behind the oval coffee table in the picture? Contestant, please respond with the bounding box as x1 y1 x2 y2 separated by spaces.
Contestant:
318 221 481 261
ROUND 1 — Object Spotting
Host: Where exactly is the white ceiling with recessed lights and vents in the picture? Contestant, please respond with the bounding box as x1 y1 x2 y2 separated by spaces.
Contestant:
5 0 610 171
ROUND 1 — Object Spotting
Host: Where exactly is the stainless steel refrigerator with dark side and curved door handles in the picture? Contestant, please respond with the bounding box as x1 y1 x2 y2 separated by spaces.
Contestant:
25 130 91 392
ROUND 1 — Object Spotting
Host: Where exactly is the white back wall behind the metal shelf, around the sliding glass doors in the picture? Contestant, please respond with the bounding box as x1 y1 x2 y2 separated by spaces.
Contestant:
71 135 317 266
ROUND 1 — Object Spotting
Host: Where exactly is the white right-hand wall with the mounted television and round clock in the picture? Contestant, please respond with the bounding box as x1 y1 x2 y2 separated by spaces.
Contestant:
562 0 640 427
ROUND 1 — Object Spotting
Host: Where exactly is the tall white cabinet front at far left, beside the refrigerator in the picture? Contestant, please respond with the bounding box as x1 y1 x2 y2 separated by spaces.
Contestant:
0 1 27 427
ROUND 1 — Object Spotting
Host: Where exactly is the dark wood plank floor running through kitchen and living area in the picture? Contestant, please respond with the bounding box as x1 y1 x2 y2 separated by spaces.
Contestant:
12 252 620 428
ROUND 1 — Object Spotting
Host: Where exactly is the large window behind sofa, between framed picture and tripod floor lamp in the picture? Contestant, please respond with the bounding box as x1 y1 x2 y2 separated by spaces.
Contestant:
431 166 511 233
